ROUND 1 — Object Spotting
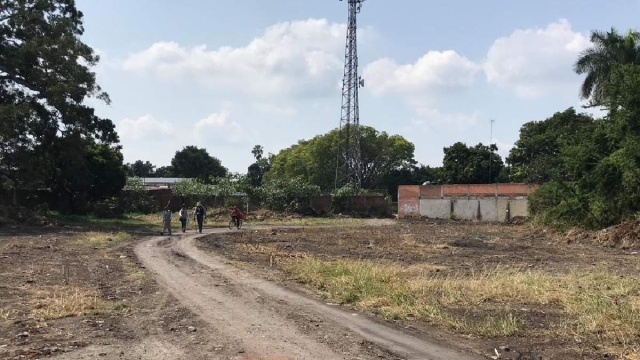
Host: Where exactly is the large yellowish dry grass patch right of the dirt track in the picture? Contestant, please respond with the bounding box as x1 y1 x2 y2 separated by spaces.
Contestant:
284 258 640 349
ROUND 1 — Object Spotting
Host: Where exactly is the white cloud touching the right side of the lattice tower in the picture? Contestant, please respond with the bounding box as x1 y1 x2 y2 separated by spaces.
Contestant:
363 50 481 95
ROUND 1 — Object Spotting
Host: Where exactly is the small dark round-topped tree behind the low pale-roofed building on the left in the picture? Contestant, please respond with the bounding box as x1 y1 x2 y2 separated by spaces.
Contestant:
171 146 227 184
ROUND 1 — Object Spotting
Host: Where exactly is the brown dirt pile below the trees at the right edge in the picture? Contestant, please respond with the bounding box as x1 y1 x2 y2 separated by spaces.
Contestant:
565 220 640 249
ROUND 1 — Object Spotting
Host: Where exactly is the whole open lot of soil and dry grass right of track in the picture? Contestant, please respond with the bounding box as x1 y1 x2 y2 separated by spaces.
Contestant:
201 222 640 359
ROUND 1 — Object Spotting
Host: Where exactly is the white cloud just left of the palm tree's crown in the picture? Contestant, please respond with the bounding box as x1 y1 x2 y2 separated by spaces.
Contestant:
484 19 590 98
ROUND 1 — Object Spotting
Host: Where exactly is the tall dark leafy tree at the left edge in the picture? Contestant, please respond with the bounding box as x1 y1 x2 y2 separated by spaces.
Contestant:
0 0 118 197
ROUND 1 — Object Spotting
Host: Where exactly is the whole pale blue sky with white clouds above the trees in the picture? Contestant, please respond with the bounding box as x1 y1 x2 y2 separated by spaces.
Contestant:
76 0 640 172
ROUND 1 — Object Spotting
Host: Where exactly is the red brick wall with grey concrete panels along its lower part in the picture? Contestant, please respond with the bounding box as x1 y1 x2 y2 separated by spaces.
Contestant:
398 184 539 222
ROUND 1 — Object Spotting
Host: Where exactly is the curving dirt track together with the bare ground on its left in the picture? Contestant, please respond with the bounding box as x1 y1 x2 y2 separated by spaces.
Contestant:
0 220 478 360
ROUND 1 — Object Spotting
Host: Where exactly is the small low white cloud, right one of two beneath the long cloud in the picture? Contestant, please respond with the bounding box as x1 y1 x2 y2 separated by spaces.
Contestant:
193 110 246 144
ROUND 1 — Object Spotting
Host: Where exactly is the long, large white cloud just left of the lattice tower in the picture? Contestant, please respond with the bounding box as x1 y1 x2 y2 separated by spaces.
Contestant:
123 19 362 96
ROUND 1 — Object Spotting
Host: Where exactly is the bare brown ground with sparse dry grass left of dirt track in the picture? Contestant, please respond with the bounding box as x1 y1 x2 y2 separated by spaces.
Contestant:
0 225 209 359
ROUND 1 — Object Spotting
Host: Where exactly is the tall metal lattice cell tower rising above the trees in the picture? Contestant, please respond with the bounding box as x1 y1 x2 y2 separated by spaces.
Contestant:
335 0 365 193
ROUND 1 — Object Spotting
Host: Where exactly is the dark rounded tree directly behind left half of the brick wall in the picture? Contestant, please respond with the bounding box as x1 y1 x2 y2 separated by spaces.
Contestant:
441 142 504 184
